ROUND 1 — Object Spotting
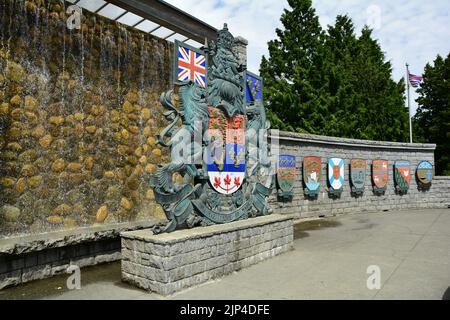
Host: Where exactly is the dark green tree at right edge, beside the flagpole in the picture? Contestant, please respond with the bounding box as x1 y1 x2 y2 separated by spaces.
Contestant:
413 54 450 175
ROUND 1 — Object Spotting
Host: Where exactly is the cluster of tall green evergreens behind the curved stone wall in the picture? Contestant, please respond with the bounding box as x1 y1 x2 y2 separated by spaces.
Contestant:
260 0 409 141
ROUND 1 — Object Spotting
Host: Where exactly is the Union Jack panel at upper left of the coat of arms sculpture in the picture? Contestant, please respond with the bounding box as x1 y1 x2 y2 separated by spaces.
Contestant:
178 45 206 88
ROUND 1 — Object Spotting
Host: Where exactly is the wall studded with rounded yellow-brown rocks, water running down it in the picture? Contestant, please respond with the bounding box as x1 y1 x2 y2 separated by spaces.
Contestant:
0 0 173 238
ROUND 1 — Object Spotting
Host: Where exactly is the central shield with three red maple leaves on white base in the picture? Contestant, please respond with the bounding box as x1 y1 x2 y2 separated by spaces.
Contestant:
207 107 246 195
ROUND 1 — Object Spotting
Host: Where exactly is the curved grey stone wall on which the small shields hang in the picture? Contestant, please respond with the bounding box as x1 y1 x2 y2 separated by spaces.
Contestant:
270 131 450 218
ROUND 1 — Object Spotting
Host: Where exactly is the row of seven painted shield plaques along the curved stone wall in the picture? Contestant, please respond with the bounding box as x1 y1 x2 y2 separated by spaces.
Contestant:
277 155 434 200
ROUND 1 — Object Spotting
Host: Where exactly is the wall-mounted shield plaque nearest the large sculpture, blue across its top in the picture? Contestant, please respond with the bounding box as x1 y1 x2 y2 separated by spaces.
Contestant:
277 155 297 201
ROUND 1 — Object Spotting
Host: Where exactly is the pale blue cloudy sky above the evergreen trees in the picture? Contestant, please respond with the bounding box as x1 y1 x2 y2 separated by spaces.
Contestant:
166 0 450 114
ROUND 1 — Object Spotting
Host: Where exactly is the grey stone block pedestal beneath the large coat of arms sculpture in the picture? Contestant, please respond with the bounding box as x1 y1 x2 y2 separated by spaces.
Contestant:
121 215 294 295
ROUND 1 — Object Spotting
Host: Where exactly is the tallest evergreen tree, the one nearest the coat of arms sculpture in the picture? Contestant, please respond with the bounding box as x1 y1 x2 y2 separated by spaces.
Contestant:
261 0 326 133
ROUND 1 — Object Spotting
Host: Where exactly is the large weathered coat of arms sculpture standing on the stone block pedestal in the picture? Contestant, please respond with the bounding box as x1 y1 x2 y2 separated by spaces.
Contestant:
149 25 275 233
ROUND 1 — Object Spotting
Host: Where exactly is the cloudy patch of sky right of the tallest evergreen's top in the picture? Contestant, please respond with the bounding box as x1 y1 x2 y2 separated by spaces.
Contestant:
313 0 450 112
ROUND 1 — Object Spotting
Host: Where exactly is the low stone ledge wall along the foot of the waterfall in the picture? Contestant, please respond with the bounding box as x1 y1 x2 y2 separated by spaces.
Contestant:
0 219 158 290
